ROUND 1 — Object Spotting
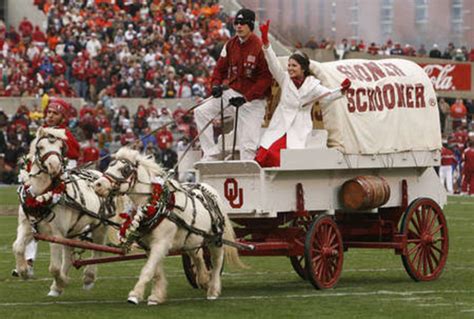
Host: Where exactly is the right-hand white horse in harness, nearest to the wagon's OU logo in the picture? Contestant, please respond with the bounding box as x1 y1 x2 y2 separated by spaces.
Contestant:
94 148 246 305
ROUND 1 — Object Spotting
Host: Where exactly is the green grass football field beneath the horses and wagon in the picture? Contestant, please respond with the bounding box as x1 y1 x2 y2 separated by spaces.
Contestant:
0 190 474 319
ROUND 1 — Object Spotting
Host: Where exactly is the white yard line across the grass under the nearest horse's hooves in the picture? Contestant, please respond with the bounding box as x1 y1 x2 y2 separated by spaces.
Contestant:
0 290 474 307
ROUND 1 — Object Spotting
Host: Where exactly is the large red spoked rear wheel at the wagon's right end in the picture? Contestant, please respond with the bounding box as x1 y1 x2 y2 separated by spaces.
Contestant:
401 198 449 281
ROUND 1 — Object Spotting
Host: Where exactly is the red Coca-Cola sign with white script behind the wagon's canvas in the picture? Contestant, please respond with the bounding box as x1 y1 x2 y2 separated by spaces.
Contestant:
420 63 471 91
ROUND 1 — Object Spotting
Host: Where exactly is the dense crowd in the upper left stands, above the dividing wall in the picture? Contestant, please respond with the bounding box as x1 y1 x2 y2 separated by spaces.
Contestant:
0 0 234 102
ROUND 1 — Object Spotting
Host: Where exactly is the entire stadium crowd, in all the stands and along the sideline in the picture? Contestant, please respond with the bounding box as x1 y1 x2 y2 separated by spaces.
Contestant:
0 0 474 194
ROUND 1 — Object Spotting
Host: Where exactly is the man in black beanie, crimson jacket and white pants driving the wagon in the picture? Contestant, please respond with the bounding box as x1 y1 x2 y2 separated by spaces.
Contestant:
195 9 272 161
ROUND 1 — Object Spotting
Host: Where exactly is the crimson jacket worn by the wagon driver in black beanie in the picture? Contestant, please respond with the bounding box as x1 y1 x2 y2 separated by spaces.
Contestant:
212 33 272 101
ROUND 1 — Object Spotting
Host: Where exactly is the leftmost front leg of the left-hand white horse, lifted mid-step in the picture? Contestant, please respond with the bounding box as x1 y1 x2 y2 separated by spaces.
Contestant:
12 206 34 279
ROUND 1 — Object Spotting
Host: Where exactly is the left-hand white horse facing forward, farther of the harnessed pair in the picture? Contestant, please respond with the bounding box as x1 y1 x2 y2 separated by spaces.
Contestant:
13 128 122 297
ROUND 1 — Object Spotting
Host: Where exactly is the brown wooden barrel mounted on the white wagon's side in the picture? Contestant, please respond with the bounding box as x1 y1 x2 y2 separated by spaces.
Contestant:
340 176 390 210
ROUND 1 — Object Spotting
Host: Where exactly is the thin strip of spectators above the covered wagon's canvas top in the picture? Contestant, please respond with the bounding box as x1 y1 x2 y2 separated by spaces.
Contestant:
295 37 474 62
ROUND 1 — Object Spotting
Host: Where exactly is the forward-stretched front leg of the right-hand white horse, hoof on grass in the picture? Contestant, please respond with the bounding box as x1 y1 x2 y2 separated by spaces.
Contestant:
128 240 174 305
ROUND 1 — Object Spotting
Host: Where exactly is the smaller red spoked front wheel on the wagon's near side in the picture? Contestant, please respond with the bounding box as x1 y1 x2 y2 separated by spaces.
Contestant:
305 215 344 289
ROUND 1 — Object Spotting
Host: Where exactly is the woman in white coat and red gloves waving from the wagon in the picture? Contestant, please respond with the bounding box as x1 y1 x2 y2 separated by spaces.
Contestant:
255 21 351 167
